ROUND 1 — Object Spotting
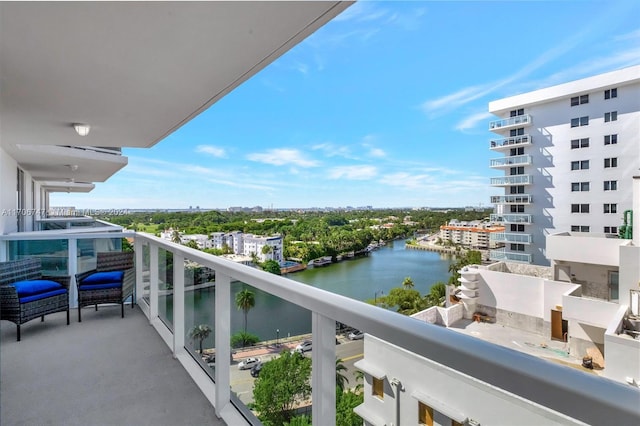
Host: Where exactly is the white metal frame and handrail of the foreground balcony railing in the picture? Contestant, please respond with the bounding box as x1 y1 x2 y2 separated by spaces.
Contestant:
5 233 640 425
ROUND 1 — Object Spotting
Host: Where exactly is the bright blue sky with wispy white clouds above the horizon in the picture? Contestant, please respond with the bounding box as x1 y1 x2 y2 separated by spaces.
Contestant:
51 0 640 208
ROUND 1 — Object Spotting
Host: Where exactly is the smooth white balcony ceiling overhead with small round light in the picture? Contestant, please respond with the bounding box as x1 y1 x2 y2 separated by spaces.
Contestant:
0 1 352 182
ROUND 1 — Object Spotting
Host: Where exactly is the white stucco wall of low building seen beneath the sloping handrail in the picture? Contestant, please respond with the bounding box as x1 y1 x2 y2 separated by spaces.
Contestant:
357 334 581 426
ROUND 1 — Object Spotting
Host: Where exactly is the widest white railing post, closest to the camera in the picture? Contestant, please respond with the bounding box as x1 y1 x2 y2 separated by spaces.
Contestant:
311 312 336 426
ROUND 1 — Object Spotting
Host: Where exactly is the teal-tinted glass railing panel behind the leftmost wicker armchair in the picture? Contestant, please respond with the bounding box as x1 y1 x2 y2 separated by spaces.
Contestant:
7 238 69 275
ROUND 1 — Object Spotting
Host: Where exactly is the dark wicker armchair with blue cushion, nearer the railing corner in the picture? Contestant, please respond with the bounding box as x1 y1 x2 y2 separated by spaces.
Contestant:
76 252 135 322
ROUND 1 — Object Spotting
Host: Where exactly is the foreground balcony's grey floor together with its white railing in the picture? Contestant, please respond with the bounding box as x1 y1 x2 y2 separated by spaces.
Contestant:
5 232 640 425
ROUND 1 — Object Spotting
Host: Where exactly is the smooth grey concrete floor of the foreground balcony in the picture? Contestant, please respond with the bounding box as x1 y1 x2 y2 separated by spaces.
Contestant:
0 306 225 426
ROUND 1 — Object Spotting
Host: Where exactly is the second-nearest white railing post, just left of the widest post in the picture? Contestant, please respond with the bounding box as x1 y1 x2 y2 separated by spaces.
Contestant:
214 271 231 417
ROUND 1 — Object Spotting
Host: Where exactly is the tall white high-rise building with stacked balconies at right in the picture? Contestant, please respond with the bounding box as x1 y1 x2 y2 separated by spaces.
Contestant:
489 66 640 265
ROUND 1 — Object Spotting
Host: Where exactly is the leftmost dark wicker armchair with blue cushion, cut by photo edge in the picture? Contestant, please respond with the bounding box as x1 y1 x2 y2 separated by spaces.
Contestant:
0 258 70 341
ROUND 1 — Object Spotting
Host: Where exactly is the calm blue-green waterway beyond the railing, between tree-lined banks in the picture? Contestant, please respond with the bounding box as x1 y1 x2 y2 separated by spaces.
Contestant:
170 240 451 347
